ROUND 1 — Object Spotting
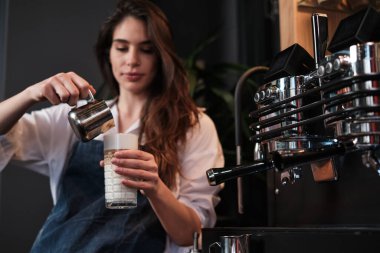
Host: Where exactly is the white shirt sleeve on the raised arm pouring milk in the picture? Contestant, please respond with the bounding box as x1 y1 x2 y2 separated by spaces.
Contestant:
0 104 76 202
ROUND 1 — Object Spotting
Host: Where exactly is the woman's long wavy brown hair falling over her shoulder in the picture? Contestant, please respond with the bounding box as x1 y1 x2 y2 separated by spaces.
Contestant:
96 0 198 189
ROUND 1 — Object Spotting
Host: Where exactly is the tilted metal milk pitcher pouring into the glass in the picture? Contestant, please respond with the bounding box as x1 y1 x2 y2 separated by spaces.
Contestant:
68 91 115 142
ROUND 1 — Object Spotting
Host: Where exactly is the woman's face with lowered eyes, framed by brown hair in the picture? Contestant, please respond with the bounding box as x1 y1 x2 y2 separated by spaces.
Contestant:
110 17 158 96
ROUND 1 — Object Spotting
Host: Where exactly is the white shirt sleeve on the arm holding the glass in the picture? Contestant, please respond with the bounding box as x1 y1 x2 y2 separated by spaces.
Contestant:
178 113 224 227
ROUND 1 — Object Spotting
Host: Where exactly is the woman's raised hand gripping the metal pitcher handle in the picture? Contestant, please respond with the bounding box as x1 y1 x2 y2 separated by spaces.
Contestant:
27 72 96 106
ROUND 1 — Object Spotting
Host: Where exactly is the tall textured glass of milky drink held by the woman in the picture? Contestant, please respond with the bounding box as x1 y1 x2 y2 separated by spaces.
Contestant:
104 133 138 209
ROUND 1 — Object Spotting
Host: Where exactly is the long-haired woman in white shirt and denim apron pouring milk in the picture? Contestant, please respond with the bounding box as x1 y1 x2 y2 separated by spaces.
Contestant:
0 0 224 252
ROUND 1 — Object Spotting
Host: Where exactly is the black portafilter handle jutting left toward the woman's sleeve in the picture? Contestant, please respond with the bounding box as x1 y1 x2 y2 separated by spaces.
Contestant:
206 161 274 185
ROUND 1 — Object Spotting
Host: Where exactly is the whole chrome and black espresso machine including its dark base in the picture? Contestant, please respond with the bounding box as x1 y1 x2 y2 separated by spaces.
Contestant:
203 7 380 253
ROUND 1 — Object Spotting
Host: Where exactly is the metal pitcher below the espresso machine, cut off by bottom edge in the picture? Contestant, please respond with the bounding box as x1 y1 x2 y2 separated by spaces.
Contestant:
209 234 251 253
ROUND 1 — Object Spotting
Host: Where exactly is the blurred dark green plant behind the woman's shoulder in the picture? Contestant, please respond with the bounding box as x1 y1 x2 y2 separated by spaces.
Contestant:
184 35 258 163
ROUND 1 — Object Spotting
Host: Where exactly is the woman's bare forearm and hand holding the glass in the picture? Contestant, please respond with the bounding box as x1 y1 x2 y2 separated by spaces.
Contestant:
100 150 201 246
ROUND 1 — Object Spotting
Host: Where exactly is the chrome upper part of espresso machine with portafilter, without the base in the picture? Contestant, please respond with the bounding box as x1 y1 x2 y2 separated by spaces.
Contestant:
207 5 380 188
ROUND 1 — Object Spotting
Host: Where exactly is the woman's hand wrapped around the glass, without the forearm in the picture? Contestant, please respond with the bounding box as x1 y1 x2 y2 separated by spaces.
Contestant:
111 149 162 197
